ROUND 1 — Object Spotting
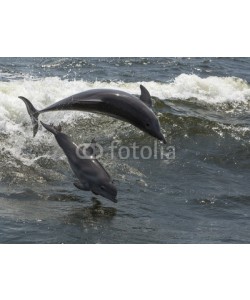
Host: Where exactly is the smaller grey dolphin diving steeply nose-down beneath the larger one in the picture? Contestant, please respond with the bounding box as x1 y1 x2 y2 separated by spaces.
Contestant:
41 122 117 203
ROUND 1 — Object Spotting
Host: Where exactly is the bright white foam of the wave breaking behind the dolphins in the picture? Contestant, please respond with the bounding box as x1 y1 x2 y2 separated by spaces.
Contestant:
0 74 250 164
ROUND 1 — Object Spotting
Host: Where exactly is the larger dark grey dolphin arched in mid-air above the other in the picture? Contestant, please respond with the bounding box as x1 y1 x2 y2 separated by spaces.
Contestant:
19 85 166 143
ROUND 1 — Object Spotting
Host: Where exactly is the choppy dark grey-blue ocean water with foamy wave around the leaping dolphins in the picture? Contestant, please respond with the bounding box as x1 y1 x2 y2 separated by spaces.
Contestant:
0 58 250 243
